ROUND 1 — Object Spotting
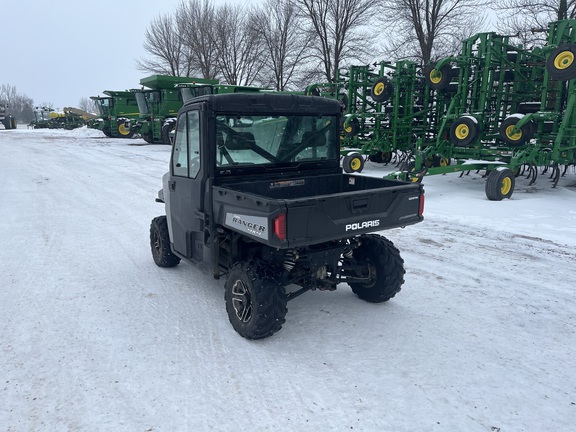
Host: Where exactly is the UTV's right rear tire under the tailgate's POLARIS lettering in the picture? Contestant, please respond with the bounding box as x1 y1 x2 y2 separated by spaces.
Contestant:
349 234 406 303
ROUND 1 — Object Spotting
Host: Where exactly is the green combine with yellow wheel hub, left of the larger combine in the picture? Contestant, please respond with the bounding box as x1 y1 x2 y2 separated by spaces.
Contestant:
88 90 140 138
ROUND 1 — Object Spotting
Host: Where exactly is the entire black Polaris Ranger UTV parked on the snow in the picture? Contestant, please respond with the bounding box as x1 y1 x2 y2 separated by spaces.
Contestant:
150 93 424 339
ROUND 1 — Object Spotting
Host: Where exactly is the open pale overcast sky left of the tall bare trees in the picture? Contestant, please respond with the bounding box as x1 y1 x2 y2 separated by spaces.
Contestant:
0 0 253 108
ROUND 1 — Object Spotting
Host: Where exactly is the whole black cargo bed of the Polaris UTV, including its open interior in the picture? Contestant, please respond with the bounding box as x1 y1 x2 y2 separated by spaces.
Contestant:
213 174 424 248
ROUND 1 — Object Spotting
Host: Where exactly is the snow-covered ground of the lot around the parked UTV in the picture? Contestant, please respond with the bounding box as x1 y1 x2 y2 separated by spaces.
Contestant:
0 129 576 432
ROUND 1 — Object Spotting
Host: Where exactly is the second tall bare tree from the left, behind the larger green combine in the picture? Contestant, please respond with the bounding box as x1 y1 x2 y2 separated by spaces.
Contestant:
176 0 217 79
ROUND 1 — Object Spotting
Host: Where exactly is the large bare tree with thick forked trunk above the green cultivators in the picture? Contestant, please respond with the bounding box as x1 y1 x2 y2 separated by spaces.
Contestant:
382 0 489 64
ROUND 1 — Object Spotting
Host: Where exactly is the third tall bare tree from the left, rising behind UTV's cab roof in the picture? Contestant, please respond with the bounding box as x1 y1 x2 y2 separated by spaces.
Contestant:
214 4 264 86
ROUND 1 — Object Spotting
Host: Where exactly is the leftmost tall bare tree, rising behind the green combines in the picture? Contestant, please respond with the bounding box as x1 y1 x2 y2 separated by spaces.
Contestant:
136 15 190 76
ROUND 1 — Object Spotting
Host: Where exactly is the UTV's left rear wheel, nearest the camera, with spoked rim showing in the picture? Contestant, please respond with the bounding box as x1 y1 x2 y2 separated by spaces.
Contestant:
224 261 288 339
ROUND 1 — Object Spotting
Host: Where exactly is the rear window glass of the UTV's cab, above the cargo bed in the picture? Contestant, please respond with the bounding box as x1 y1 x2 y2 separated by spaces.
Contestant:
216 115 339 167
